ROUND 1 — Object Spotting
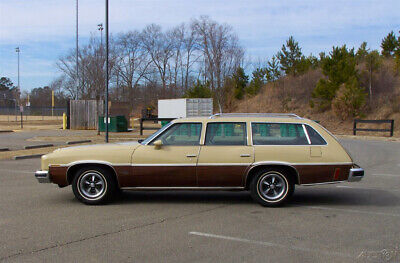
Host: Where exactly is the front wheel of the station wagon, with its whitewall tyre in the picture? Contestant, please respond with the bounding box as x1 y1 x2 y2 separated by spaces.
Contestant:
72 167 118 205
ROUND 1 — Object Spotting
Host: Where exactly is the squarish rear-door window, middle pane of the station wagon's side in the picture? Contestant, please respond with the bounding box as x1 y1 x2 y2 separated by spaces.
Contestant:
205 122 247 145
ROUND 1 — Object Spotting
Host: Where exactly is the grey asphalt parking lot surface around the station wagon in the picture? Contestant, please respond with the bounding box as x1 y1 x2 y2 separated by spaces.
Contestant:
0 139 400 262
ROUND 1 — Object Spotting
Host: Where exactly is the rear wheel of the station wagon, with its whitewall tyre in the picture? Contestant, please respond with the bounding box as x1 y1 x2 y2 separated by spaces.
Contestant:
250 169 294 206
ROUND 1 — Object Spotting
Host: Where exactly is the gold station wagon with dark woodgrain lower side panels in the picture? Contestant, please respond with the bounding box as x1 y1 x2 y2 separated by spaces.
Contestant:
35 114 364 206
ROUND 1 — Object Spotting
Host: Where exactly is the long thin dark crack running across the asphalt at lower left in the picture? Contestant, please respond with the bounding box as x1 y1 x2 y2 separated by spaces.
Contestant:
0 205 229 261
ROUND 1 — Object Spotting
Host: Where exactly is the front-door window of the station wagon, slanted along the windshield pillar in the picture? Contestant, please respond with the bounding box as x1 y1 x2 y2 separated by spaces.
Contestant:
150 123 202 145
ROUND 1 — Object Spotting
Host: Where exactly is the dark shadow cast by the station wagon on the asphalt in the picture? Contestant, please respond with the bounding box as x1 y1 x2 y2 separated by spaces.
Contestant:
107 187 400 207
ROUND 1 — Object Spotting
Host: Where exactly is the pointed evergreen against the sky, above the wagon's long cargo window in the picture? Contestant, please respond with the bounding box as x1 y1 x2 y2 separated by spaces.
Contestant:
276 36 302 75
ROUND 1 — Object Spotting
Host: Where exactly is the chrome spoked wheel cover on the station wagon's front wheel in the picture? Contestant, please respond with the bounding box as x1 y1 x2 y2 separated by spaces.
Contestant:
78 171 107 200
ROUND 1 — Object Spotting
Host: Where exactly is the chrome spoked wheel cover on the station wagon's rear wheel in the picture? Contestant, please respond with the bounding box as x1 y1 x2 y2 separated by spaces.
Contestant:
257 172 288 201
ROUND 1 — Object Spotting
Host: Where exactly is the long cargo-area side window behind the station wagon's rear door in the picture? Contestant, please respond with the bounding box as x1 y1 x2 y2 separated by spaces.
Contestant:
251 123 308 145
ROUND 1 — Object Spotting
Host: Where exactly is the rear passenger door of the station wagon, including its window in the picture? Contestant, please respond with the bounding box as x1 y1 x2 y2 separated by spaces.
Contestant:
197 122 254 187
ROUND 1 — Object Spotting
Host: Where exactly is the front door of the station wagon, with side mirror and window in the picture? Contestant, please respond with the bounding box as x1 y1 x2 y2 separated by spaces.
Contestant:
130 122 202 187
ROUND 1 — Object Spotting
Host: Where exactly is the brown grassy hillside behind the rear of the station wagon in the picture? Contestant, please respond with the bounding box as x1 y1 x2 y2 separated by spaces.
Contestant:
228 58 400 137
